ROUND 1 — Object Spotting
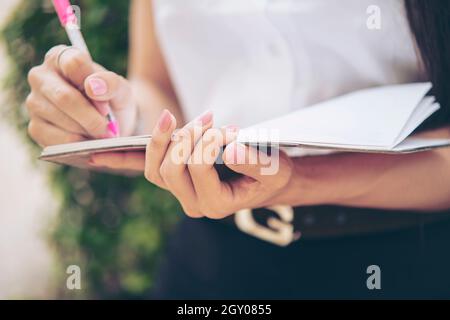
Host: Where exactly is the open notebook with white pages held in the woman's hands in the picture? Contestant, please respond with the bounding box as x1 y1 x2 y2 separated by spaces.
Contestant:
40 83 450 167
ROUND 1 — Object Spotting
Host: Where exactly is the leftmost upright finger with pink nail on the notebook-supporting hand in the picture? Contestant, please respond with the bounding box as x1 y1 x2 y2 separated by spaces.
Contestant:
145 110 177 189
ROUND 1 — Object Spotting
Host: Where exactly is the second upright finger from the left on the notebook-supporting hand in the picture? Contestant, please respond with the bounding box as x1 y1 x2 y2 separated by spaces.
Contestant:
161 111 213 217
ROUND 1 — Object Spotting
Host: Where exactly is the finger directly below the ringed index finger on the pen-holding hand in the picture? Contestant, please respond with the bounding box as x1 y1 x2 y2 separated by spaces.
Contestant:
40 73 111 138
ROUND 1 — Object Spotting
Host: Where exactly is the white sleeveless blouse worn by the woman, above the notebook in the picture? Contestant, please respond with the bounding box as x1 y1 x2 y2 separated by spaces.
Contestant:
153 0 423 127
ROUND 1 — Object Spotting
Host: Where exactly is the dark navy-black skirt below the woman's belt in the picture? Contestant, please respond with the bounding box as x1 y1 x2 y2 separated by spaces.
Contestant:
152 208 450 299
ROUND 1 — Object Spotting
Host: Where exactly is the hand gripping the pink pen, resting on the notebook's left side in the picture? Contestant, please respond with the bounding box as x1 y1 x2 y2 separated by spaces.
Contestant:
26 45 137 146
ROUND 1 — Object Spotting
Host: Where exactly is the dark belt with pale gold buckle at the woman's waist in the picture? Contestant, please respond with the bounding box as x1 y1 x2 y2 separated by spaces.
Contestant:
224 206 450 246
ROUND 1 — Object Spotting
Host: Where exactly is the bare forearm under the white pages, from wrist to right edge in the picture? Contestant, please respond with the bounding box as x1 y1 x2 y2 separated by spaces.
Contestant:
287 127 450 212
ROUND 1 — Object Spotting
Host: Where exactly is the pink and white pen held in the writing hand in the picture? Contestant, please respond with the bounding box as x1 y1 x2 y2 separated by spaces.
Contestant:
53 0 119 136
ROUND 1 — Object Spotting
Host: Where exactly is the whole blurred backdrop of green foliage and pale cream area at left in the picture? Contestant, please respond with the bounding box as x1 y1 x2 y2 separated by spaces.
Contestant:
0 0 180 299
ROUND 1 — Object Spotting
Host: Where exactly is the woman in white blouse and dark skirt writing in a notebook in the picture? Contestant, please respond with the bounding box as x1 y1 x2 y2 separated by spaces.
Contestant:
27 0 450 298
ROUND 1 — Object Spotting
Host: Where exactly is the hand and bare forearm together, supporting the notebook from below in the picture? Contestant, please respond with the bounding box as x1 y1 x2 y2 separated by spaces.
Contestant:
88 113 450 218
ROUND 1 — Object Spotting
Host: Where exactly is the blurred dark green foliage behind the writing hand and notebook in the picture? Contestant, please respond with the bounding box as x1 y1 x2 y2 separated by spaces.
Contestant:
2 0 180 298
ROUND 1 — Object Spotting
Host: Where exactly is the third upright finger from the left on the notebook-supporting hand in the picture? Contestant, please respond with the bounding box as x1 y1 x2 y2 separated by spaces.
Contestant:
189 127 238 219
